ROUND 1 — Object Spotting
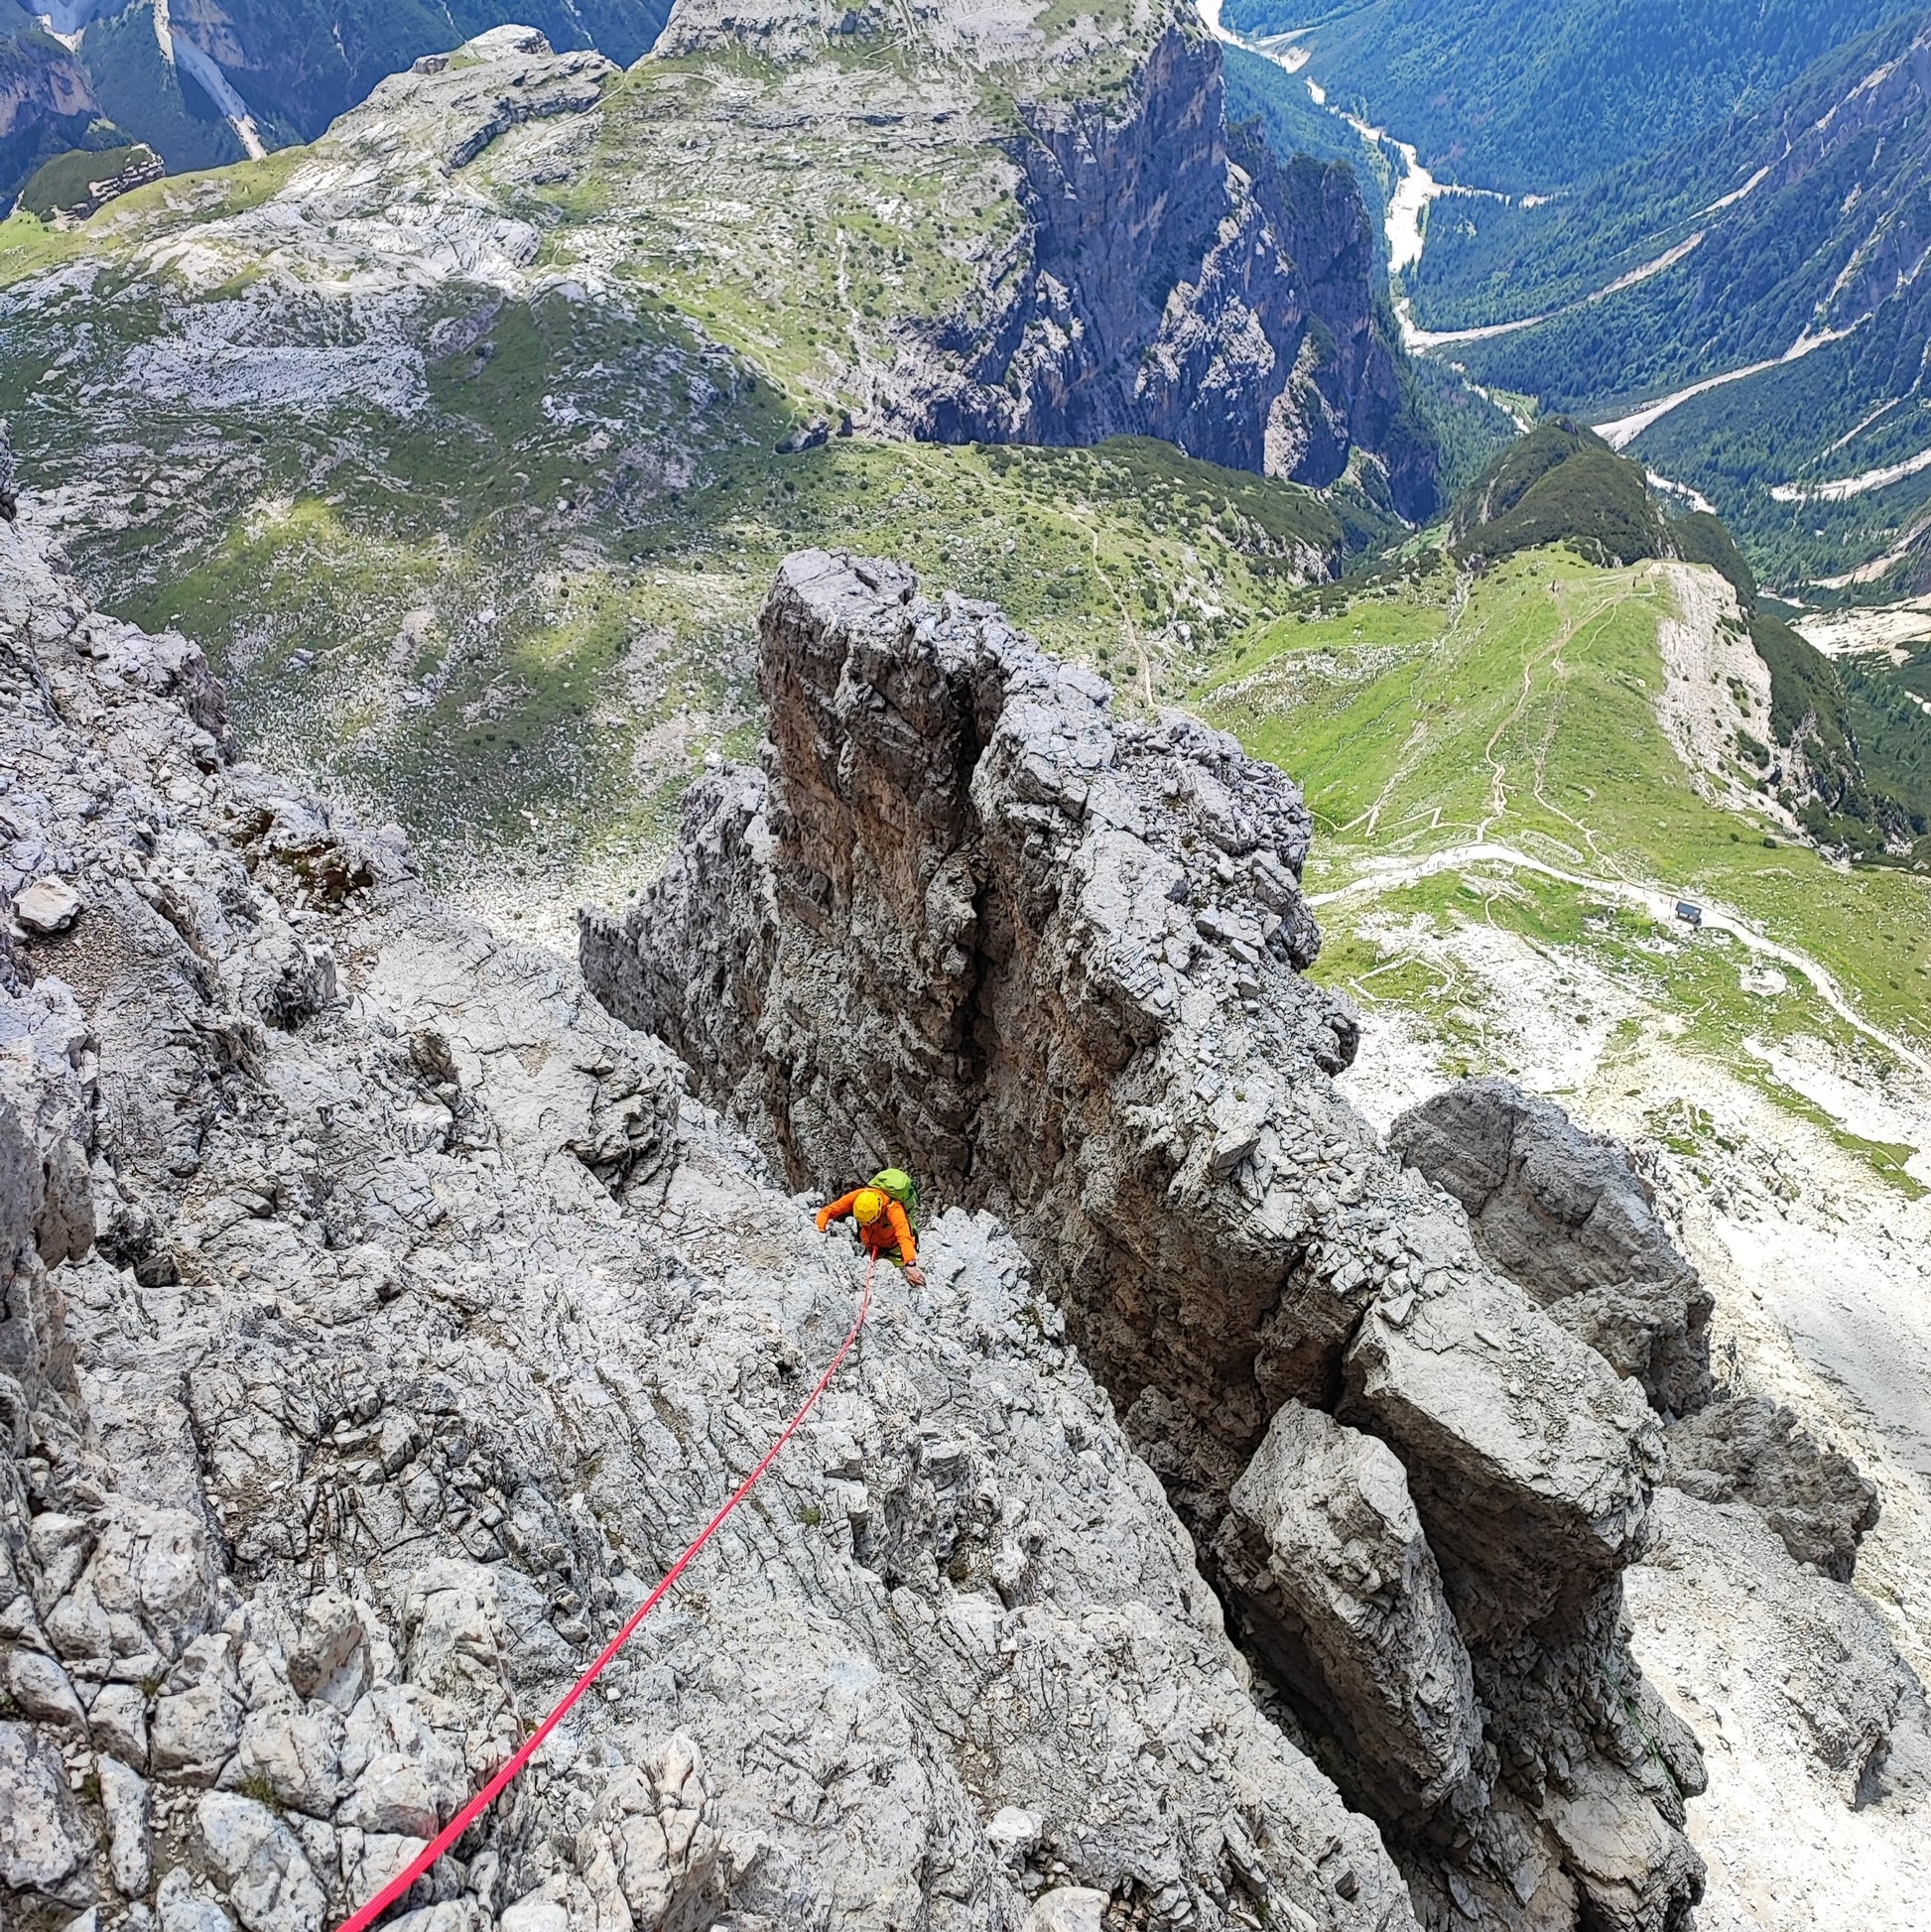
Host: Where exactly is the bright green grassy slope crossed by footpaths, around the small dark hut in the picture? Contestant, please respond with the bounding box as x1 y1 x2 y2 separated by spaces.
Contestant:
1199 551 1931 1179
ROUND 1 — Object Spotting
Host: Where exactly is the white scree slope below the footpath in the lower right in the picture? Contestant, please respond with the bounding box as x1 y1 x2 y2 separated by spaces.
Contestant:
1344 865 1931 1932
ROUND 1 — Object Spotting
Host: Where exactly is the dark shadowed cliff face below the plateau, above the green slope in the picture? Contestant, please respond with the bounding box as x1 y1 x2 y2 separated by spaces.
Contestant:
899 23 1438 522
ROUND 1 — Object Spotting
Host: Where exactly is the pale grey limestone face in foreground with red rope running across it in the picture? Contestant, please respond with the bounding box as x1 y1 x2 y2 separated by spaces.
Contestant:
0 531 1415 1932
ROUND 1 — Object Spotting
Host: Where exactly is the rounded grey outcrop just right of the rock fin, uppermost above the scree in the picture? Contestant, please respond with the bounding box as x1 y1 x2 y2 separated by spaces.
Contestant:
1388 1080 1711 1418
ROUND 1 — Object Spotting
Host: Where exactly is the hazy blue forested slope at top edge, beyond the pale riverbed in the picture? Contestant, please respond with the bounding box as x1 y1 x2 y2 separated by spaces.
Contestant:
1225 0 1906 193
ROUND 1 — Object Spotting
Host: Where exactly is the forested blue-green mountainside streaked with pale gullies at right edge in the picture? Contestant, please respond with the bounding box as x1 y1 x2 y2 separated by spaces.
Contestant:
1368 14 1931 597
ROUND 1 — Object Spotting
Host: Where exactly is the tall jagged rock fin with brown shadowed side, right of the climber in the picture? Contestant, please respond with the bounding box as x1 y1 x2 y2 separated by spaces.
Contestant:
581 553 1701 1932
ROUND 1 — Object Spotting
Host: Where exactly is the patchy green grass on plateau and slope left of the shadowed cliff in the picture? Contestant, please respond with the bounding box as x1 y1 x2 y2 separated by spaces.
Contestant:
0 14 1422 916
